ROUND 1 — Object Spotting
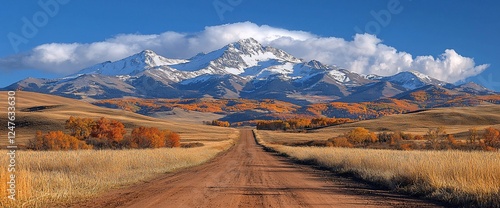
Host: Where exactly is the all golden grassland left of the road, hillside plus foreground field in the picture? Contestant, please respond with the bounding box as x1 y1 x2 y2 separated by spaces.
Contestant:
0 92 239 207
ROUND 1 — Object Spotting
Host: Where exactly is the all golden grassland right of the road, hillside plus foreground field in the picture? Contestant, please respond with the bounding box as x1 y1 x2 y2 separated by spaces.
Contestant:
255 110 500 207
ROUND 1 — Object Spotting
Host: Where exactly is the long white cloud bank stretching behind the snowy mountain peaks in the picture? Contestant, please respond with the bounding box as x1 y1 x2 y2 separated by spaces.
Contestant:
0 22 489 82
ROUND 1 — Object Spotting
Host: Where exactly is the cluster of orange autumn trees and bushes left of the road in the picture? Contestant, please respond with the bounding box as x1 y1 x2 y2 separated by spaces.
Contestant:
27 116 180 150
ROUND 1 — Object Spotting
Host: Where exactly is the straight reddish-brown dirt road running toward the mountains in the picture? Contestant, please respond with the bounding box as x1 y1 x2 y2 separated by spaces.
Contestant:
76 130 444 208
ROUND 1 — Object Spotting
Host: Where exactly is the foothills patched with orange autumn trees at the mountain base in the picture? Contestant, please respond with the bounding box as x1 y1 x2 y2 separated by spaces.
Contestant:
93 94 500 124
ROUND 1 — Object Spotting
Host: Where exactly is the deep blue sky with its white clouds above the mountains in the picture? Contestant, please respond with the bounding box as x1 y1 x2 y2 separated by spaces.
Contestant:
0 0 500 90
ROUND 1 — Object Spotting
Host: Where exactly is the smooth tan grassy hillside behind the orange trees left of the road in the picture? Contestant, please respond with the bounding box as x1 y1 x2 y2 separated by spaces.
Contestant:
0 91 237 146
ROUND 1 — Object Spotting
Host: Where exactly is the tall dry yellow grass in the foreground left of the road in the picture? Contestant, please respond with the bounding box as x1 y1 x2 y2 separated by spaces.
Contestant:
0 140 234 207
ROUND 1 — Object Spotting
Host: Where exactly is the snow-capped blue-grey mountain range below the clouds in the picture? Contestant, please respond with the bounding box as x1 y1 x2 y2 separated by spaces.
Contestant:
6 38 492 104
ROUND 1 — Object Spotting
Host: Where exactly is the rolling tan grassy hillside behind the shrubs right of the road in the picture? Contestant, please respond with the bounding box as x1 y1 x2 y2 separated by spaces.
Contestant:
259 104 500 143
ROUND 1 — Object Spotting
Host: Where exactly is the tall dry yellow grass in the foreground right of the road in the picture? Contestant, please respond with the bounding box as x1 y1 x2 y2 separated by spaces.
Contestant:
257 131 500 207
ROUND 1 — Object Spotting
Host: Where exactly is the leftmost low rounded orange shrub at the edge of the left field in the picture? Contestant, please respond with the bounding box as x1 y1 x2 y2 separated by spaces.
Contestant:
27 131 92 150
